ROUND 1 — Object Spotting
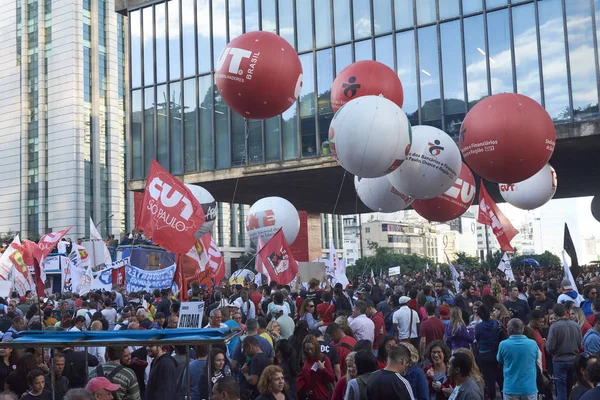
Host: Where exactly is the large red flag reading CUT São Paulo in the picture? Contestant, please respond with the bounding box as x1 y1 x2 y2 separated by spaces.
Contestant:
138 160 204 254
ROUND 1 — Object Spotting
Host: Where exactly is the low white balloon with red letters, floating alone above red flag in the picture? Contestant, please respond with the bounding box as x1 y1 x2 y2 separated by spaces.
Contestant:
246 197 300 244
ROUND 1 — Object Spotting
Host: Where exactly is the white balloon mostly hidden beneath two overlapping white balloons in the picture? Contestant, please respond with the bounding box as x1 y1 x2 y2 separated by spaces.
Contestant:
354 176 414 212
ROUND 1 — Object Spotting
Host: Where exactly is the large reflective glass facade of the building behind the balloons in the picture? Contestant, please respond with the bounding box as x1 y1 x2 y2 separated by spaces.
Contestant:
128 0 600 180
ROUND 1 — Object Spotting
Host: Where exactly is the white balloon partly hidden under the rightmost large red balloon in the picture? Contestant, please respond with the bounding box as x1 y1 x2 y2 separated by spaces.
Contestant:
498 164 557 210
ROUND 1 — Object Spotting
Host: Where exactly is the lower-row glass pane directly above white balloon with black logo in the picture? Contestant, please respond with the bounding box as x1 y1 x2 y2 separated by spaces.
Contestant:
417 26 442 128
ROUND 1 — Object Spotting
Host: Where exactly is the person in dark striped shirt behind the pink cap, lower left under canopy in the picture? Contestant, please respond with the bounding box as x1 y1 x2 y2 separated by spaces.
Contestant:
89 346 141 400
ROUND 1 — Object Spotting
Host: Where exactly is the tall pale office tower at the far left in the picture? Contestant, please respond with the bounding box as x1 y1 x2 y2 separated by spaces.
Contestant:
0 0 127 238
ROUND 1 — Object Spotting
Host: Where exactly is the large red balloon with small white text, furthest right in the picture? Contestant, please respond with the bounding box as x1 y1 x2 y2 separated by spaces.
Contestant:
459 93 556 183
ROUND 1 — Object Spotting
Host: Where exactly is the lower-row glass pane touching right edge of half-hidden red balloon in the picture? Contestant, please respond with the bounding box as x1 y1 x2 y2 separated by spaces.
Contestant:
396 31 419 125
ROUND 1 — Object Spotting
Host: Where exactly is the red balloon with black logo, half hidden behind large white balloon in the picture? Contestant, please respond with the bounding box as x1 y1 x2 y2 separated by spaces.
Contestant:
331 60 404 111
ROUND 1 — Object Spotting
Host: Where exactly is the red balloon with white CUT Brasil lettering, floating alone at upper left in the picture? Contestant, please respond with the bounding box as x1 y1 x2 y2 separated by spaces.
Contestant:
215 31 302 119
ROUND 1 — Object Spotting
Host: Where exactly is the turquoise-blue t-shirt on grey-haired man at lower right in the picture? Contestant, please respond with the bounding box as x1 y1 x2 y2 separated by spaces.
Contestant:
496 335 539 396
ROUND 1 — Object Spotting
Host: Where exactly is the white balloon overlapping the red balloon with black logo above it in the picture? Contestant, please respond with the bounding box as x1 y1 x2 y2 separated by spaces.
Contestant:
329 96 411 178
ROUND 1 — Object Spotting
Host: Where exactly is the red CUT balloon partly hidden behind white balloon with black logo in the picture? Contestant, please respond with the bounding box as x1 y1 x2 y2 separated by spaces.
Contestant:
412 163 475 222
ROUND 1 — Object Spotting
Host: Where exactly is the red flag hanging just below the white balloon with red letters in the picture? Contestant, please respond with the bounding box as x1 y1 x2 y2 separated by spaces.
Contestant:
257 229 298 285
